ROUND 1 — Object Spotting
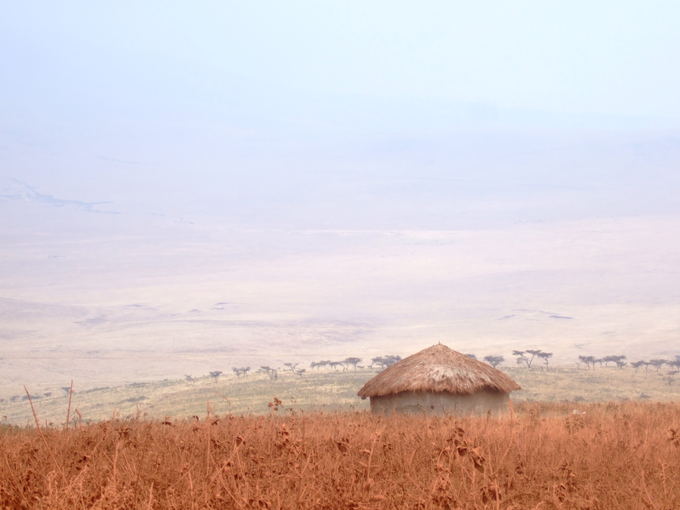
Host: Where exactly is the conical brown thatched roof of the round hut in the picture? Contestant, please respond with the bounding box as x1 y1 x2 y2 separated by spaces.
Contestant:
359 344 521 398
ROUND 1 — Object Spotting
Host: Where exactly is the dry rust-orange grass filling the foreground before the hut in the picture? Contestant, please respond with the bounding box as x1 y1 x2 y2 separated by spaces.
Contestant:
0 404 680 510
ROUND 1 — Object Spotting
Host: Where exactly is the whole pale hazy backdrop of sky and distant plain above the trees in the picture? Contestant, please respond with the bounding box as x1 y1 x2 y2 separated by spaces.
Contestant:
0 2 680 391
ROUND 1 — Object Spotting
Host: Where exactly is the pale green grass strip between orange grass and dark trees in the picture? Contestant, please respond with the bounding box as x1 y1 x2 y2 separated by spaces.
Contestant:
0 367 680 425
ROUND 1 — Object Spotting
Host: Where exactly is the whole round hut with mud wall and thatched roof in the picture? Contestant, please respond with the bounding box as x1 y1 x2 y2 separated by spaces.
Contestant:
359 344 521 415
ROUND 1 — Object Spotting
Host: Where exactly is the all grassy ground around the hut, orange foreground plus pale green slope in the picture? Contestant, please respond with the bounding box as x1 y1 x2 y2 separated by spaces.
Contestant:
0 367 680 510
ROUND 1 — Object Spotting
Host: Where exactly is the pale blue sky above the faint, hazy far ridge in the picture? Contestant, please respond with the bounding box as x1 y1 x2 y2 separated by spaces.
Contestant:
0 0 680 116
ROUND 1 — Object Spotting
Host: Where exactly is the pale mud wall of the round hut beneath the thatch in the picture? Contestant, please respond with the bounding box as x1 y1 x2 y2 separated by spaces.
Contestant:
371 391 510 416
